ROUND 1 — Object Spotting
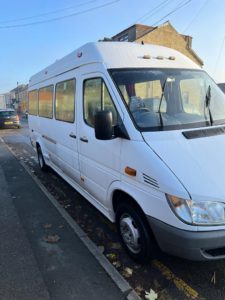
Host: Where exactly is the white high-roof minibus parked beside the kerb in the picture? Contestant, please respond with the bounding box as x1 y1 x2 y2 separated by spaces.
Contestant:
29 42 225 262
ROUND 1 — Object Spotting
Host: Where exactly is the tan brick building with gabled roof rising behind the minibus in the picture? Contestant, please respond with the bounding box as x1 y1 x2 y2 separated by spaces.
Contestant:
112 22 203 66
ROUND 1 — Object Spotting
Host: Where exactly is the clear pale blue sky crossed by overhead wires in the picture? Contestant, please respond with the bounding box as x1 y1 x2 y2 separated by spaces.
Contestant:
0 0 225 94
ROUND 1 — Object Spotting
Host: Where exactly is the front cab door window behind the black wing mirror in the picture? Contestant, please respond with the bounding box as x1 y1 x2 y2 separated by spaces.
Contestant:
84 78 118 127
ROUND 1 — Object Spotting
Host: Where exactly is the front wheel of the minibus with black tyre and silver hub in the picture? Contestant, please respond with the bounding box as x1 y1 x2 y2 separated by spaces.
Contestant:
116 203 157 264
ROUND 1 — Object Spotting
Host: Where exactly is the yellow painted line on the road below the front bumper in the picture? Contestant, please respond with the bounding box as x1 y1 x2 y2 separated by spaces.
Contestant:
152 259 199 299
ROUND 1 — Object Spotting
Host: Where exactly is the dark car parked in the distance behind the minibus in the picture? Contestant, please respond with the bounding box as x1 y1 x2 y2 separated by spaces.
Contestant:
0 109 21 128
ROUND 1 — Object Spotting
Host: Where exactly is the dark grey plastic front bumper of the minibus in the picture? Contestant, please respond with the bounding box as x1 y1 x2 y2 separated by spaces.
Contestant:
147 216 225 260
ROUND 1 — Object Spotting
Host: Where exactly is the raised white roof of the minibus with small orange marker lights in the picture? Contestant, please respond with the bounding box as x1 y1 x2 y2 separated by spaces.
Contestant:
29 42 201 87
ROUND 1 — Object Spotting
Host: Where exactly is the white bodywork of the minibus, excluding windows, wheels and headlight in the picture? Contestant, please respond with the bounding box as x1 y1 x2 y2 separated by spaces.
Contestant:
28 42 225 259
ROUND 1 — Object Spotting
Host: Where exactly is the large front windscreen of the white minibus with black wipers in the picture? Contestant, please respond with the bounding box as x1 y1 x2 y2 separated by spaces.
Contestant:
110 69 225 131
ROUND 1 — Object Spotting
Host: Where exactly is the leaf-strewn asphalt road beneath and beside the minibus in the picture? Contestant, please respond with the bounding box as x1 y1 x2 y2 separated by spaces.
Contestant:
0 123 225 300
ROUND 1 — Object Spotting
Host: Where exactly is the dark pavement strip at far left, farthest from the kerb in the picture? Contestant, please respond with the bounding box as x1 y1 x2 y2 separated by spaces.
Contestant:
0 154 50 300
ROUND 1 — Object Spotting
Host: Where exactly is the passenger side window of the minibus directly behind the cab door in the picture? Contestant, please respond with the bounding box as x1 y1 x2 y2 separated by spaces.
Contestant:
55 79 75 123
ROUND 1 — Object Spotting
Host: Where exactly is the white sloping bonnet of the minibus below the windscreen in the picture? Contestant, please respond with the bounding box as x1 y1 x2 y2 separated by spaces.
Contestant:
143 131 225 203
